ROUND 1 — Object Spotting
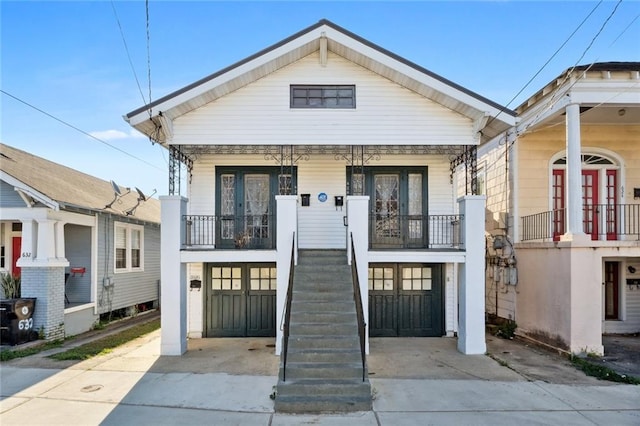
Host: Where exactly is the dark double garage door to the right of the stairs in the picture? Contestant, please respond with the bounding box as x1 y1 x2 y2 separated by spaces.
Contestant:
369 264 444 337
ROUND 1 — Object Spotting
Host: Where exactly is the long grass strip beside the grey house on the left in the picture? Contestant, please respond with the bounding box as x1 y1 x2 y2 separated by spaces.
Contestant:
49 319 160 361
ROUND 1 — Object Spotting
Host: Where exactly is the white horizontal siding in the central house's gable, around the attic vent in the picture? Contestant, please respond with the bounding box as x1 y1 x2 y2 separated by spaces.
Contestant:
172 54 474 145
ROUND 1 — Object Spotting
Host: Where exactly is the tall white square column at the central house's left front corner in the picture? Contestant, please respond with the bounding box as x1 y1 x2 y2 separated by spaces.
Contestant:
160 195 187 356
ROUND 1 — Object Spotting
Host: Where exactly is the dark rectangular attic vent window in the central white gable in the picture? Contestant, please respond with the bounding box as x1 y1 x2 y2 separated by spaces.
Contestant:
291 85 356 108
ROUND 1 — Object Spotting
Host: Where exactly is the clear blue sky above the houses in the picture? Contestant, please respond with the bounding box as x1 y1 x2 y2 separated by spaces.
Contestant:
0 0 640 195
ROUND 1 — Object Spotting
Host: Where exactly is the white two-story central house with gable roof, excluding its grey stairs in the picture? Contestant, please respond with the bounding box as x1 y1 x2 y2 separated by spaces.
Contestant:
125 20 515 362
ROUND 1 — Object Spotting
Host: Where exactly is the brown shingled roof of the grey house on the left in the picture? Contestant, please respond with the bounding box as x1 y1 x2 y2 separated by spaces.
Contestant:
0 143 160 223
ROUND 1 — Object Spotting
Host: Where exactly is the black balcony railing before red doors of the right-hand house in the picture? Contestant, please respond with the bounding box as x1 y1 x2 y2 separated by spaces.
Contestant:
521 204 640 241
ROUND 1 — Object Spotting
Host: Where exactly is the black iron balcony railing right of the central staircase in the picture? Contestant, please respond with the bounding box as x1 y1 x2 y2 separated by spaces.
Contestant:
369 213 464 249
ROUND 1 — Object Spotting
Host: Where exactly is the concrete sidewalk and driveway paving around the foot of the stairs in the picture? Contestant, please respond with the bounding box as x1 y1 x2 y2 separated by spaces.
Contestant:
0 314 640 426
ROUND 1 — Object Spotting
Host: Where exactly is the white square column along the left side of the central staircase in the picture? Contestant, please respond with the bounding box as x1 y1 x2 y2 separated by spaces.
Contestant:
276 195 298 355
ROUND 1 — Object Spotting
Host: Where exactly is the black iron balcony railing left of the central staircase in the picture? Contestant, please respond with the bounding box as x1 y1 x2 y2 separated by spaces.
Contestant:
182 214 276 249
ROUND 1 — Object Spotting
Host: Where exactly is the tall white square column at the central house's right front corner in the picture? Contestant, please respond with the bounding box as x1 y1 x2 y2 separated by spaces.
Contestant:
458 195 487 355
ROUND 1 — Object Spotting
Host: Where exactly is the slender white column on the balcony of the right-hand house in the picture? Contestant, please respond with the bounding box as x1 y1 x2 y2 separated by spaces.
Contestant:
560 104 587 241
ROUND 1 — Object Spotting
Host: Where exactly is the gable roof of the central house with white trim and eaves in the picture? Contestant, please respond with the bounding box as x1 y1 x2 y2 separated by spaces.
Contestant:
124 19 515 143
